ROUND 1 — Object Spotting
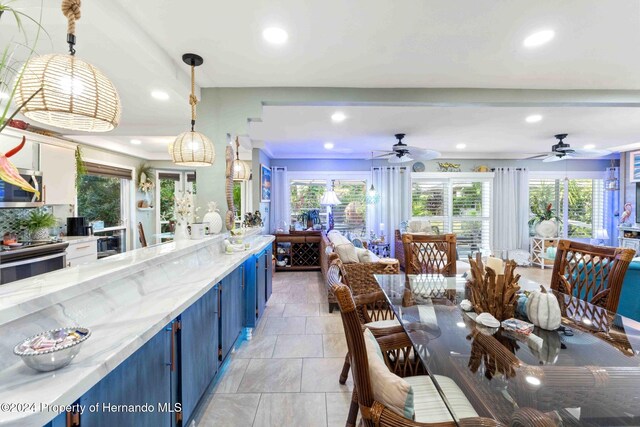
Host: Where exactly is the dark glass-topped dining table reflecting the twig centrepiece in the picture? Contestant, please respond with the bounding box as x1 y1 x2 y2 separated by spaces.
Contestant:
375 274 640 426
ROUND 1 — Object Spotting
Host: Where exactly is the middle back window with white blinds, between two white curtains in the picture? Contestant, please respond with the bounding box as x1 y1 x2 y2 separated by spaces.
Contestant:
411 178 492 257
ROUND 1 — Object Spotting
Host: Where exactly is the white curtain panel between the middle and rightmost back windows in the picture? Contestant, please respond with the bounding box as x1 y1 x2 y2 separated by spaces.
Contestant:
491 168 529 258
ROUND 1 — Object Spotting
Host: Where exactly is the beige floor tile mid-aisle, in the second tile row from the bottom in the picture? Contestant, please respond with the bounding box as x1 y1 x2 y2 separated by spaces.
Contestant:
238 359 302 393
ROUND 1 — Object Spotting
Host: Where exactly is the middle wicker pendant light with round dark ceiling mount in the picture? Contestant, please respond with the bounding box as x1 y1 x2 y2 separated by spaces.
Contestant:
169 53 216 167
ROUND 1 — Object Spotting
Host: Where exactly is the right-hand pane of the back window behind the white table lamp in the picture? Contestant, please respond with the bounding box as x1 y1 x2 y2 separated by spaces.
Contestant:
333 180 367 236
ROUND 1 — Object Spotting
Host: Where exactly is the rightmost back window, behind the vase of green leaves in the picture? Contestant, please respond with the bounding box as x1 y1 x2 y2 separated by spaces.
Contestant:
529 177 604 239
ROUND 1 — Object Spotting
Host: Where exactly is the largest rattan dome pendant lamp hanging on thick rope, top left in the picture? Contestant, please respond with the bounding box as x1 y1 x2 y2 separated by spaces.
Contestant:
16 0 121 132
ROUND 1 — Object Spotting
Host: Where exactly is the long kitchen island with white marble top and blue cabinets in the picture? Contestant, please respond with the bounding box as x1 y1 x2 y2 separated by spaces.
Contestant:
0 231 273 426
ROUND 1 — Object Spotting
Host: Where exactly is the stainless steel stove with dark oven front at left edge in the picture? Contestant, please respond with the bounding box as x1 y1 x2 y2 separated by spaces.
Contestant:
0 241 69 285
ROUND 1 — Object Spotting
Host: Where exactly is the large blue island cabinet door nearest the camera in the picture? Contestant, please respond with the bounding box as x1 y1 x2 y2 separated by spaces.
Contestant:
80 325 176 427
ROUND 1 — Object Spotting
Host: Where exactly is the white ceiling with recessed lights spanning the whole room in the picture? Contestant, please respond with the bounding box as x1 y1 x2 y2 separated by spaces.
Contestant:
0 0 640 159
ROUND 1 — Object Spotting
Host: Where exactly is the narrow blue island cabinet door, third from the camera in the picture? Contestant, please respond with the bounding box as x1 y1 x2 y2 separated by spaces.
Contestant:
219 265 245 360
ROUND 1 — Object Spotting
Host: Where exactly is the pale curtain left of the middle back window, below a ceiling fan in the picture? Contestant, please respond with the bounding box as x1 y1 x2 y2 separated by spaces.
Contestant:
369 167 411 257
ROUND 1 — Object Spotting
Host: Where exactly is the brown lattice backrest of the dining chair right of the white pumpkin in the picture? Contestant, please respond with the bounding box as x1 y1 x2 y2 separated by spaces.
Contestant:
551 240 635 313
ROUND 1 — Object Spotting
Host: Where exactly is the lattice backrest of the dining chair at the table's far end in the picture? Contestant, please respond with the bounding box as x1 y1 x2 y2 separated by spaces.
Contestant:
402 234 457 276
